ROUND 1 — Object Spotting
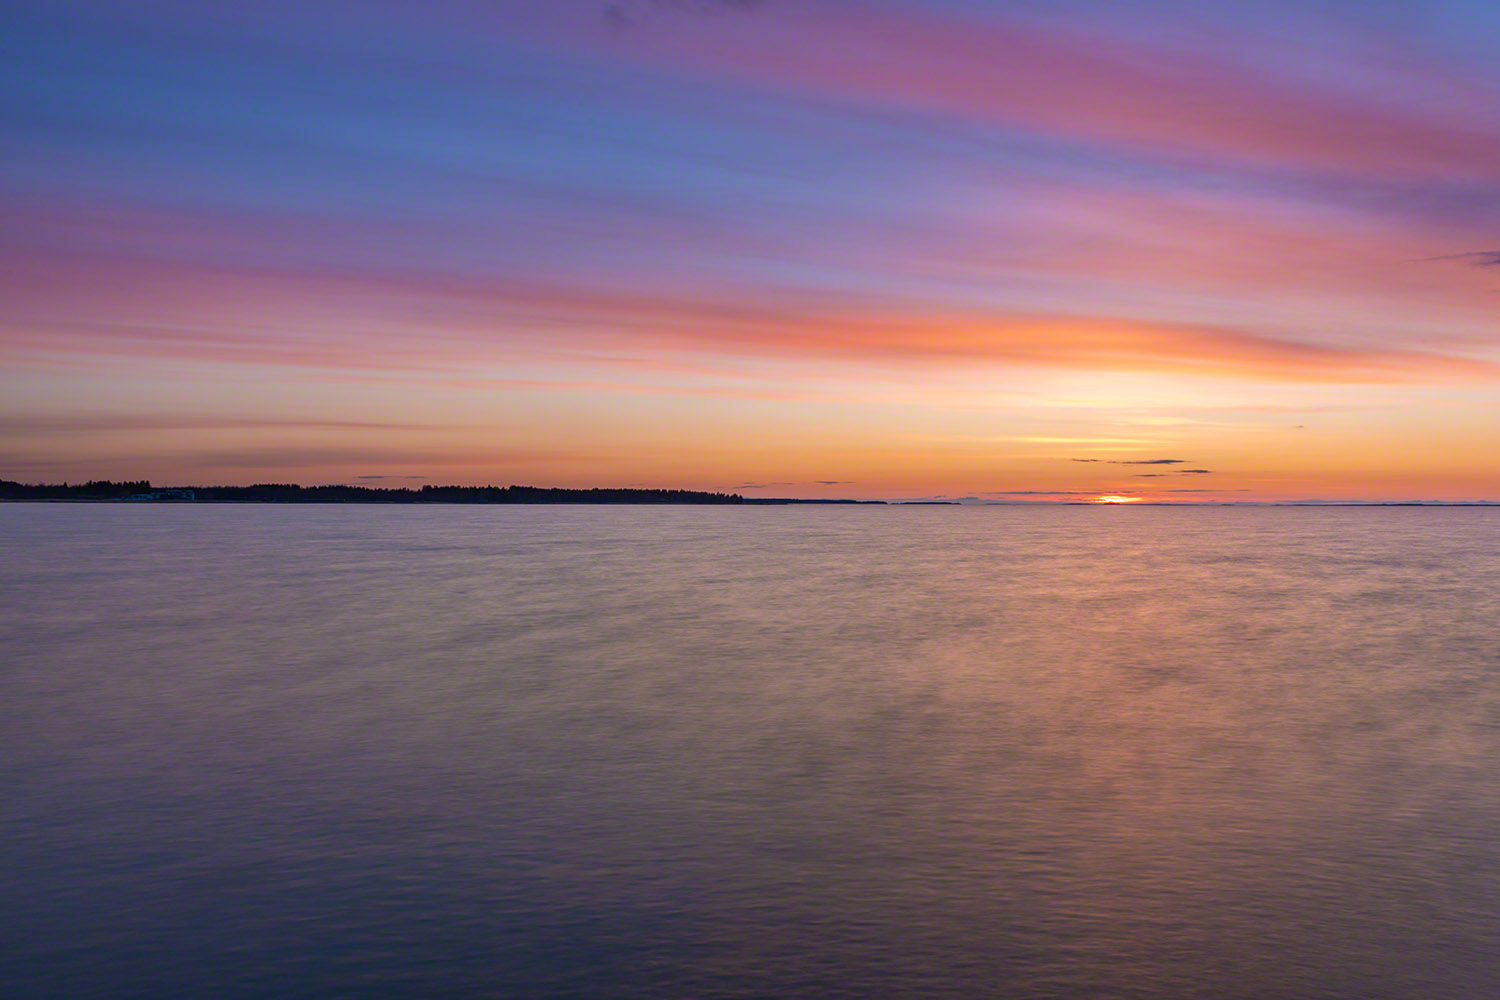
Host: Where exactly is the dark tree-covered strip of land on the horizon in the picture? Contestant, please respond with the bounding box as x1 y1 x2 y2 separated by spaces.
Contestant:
0 480 885 505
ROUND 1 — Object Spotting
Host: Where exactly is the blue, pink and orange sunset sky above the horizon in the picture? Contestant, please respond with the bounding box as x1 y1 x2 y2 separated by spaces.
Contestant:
0 0 1500 501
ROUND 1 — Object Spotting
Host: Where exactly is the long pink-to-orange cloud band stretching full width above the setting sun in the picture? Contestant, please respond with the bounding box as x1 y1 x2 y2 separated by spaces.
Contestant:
0 242 1500 382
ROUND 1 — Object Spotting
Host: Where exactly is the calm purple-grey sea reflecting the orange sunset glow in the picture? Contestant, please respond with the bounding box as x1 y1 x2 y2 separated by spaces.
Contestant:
0 504 1500 1000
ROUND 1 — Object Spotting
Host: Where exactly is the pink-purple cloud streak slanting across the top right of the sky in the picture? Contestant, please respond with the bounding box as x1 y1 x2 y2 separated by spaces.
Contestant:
561 3 1500 178
